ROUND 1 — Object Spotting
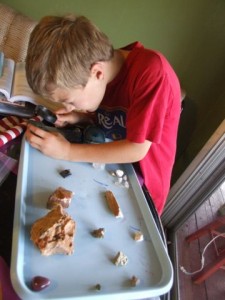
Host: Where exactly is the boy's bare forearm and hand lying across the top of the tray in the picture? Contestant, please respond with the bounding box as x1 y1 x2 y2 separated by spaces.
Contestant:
26 124 151 163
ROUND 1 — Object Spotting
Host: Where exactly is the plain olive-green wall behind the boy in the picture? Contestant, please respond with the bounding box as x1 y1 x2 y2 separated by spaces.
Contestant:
1 0 225 180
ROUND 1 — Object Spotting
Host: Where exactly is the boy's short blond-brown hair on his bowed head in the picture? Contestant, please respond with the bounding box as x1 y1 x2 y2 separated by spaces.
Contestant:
26 15 114 95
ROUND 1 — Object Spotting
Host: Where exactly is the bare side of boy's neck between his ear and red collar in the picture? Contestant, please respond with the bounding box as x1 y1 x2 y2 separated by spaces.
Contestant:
106 49 129 83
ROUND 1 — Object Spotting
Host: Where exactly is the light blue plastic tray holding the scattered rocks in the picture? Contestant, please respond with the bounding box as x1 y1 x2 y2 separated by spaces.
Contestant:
11 140 173 300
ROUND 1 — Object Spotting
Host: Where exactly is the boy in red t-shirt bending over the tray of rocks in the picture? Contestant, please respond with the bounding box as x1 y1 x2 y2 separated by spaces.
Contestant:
26 15 181 215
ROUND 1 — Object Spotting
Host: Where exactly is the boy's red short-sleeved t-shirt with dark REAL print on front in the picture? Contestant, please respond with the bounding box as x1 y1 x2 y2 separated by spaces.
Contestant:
96 42 181 214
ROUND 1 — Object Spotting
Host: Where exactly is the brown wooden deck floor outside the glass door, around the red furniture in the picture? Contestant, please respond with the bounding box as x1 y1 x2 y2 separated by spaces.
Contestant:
177 179 225 300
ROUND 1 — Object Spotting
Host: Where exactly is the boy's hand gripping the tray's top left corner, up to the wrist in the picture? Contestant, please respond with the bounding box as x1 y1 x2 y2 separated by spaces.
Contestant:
25 124 71 159
